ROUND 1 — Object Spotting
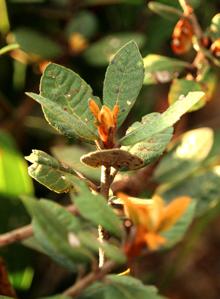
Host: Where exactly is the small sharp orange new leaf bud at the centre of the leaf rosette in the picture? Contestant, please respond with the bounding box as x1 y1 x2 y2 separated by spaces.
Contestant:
89 100 119 148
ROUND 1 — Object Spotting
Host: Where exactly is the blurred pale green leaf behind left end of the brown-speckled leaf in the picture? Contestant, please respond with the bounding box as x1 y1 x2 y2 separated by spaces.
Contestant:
51 145 100 181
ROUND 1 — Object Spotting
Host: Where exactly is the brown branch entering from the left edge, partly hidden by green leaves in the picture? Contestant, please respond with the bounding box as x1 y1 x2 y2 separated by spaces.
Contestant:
0 205 77 247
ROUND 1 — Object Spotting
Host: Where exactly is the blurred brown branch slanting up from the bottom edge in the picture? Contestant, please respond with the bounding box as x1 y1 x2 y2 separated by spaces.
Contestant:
63 261 116 297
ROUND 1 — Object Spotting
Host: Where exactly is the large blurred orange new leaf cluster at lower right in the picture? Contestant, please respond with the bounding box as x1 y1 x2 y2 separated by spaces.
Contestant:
117 193 190 258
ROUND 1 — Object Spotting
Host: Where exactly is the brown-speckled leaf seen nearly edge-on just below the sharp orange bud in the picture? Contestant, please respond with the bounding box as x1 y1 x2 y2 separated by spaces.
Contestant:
80 149 144 170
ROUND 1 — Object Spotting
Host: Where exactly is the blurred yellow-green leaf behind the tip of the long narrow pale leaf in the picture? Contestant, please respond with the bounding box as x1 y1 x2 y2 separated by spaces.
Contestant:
168 79 206 111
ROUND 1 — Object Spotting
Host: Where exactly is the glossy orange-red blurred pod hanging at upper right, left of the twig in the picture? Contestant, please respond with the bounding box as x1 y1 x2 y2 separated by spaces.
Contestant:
171 18 193 55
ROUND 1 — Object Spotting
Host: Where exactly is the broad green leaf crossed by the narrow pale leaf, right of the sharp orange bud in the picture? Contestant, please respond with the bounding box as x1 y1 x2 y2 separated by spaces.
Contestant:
121 113 173 166
